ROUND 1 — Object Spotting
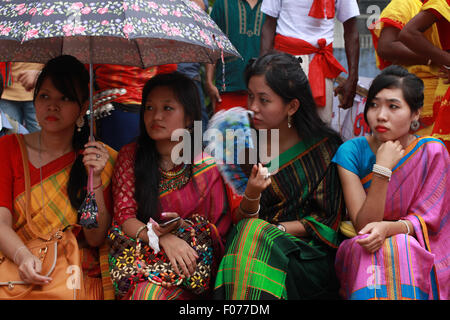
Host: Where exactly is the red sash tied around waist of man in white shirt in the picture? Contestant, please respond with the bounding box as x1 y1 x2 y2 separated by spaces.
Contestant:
274 34 347 107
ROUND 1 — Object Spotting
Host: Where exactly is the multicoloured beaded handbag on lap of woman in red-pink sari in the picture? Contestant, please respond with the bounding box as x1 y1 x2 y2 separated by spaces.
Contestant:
108 215 214 298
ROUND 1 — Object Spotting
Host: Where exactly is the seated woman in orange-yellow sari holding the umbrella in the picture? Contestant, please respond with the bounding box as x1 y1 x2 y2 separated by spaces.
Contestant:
0 55 115 300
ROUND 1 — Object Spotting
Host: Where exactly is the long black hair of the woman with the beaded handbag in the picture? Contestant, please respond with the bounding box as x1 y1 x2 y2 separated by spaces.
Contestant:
134 72 201 223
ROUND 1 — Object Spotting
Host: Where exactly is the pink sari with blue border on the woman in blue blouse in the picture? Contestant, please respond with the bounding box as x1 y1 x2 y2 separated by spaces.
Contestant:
335 137 450 300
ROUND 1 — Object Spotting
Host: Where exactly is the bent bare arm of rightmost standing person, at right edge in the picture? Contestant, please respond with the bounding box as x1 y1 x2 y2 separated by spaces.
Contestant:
399 11 450 66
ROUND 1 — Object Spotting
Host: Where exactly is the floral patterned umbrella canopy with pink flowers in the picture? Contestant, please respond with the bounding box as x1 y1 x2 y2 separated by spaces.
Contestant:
0 0 240 68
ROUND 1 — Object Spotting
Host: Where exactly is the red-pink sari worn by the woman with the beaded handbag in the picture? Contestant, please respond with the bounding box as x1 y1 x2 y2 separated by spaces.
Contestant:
113 143 240 300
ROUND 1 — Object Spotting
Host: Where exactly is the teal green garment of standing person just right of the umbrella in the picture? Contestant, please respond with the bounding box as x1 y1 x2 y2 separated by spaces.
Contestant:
211 0 265 92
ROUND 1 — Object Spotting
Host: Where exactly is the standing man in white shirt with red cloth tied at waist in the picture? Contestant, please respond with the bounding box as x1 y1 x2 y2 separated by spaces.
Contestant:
261 0 359 125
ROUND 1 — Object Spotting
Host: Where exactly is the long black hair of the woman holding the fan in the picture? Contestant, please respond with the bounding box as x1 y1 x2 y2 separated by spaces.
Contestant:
244 52 340 140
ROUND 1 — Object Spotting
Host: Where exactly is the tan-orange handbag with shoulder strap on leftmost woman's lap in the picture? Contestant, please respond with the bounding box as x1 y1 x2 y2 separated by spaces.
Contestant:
0 135 82 300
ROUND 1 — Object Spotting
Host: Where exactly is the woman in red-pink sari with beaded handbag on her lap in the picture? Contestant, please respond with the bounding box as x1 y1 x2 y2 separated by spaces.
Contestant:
113 72 239 300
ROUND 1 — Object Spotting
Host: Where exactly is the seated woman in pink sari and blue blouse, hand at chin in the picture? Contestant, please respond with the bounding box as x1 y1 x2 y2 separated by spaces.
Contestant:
333 66 450 299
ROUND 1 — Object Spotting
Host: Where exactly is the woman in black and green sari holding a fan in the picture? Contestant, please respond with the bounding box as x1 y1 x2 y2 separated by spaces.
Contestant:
215 53 344 300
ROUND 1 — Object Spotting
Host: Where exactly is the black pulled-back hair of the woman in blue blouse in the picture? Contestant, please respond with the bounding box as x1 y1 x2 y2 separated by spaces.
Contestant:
364 65 424 123
